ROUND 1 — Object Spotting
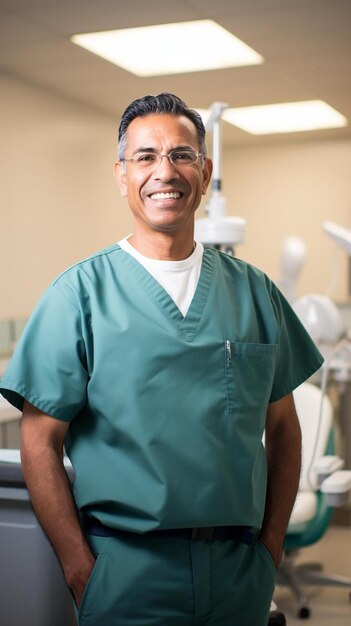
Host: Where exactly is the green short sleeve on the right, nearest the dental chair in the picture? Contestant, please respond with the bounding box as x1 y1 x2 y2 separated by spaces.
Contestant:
270 283 323 402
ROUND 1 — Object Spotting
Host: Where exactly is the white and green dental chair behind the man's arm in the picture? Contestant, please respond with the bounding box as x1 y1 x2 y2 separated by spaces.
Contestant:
277 383 351 619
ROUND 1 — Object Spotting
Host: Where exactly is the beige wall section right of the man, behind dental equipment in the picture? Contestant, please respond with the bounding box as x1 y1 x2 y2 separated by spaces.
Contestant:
217 139 351 302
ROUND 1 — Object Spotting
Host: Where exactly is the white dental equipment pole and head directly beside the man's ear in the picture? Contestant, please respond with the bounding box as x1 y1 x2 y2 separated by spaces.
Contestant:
195 102 246 255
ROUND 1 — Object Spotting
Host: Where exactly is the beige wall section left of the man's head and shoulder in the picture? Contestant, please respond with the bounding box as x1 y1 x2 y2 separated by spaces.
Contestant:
0 72 131 319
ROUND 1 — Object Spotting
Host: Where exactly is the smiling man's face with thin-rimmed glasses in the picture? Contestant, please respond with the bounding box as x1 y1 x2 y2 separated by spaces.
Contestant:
115 114 212 232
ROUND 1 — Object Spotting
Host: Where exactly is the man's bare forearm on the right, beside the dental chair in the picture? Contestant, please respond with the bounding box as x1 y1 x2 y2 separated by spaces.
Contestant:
260 394 301 565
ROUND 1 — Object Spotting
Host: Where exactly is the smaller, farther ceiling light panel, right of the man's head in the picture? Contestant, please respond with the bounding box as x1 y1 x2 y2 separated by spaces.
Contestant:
223 100 348 135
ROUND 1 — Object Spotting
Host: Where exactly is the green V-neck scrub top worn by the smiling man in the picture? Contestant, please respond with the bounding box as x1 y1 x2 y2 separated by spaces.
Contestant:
0 245 323 533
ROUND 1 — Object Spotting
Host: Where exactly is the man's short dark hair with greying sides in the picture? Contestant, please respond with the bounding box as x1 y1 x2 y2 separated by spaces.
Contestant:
118 93 206 159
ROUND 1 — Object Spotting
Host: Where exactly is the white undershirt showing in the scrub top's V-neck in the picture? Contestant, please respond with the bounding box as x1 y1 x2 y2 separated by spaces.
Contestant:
118 235 204 317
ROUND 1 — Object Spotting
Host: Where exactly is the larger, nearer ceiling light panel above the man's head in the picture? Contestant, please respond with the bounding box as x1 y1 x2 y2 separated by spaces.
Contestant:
71 20 264 76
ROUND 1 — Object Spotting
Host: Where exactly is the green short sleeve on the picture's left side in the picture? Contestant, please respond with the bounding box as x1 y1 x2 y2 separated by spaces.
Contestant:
0 284 88 421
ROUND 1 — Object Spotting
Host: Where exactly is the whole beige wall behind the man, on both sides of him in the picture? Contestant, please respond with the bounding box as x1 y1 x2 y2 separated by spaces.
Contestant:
0 76 351 319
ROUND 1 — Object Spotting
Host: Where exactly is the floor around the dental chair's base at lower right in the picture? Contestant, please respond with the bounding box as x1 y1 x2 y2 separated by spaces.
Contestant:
274 526 351 626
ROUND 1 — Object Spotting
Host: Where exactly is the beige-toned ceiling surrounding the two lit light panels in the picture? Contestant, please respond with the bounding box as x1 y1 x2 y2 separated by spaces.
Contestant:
0 0 351 144
